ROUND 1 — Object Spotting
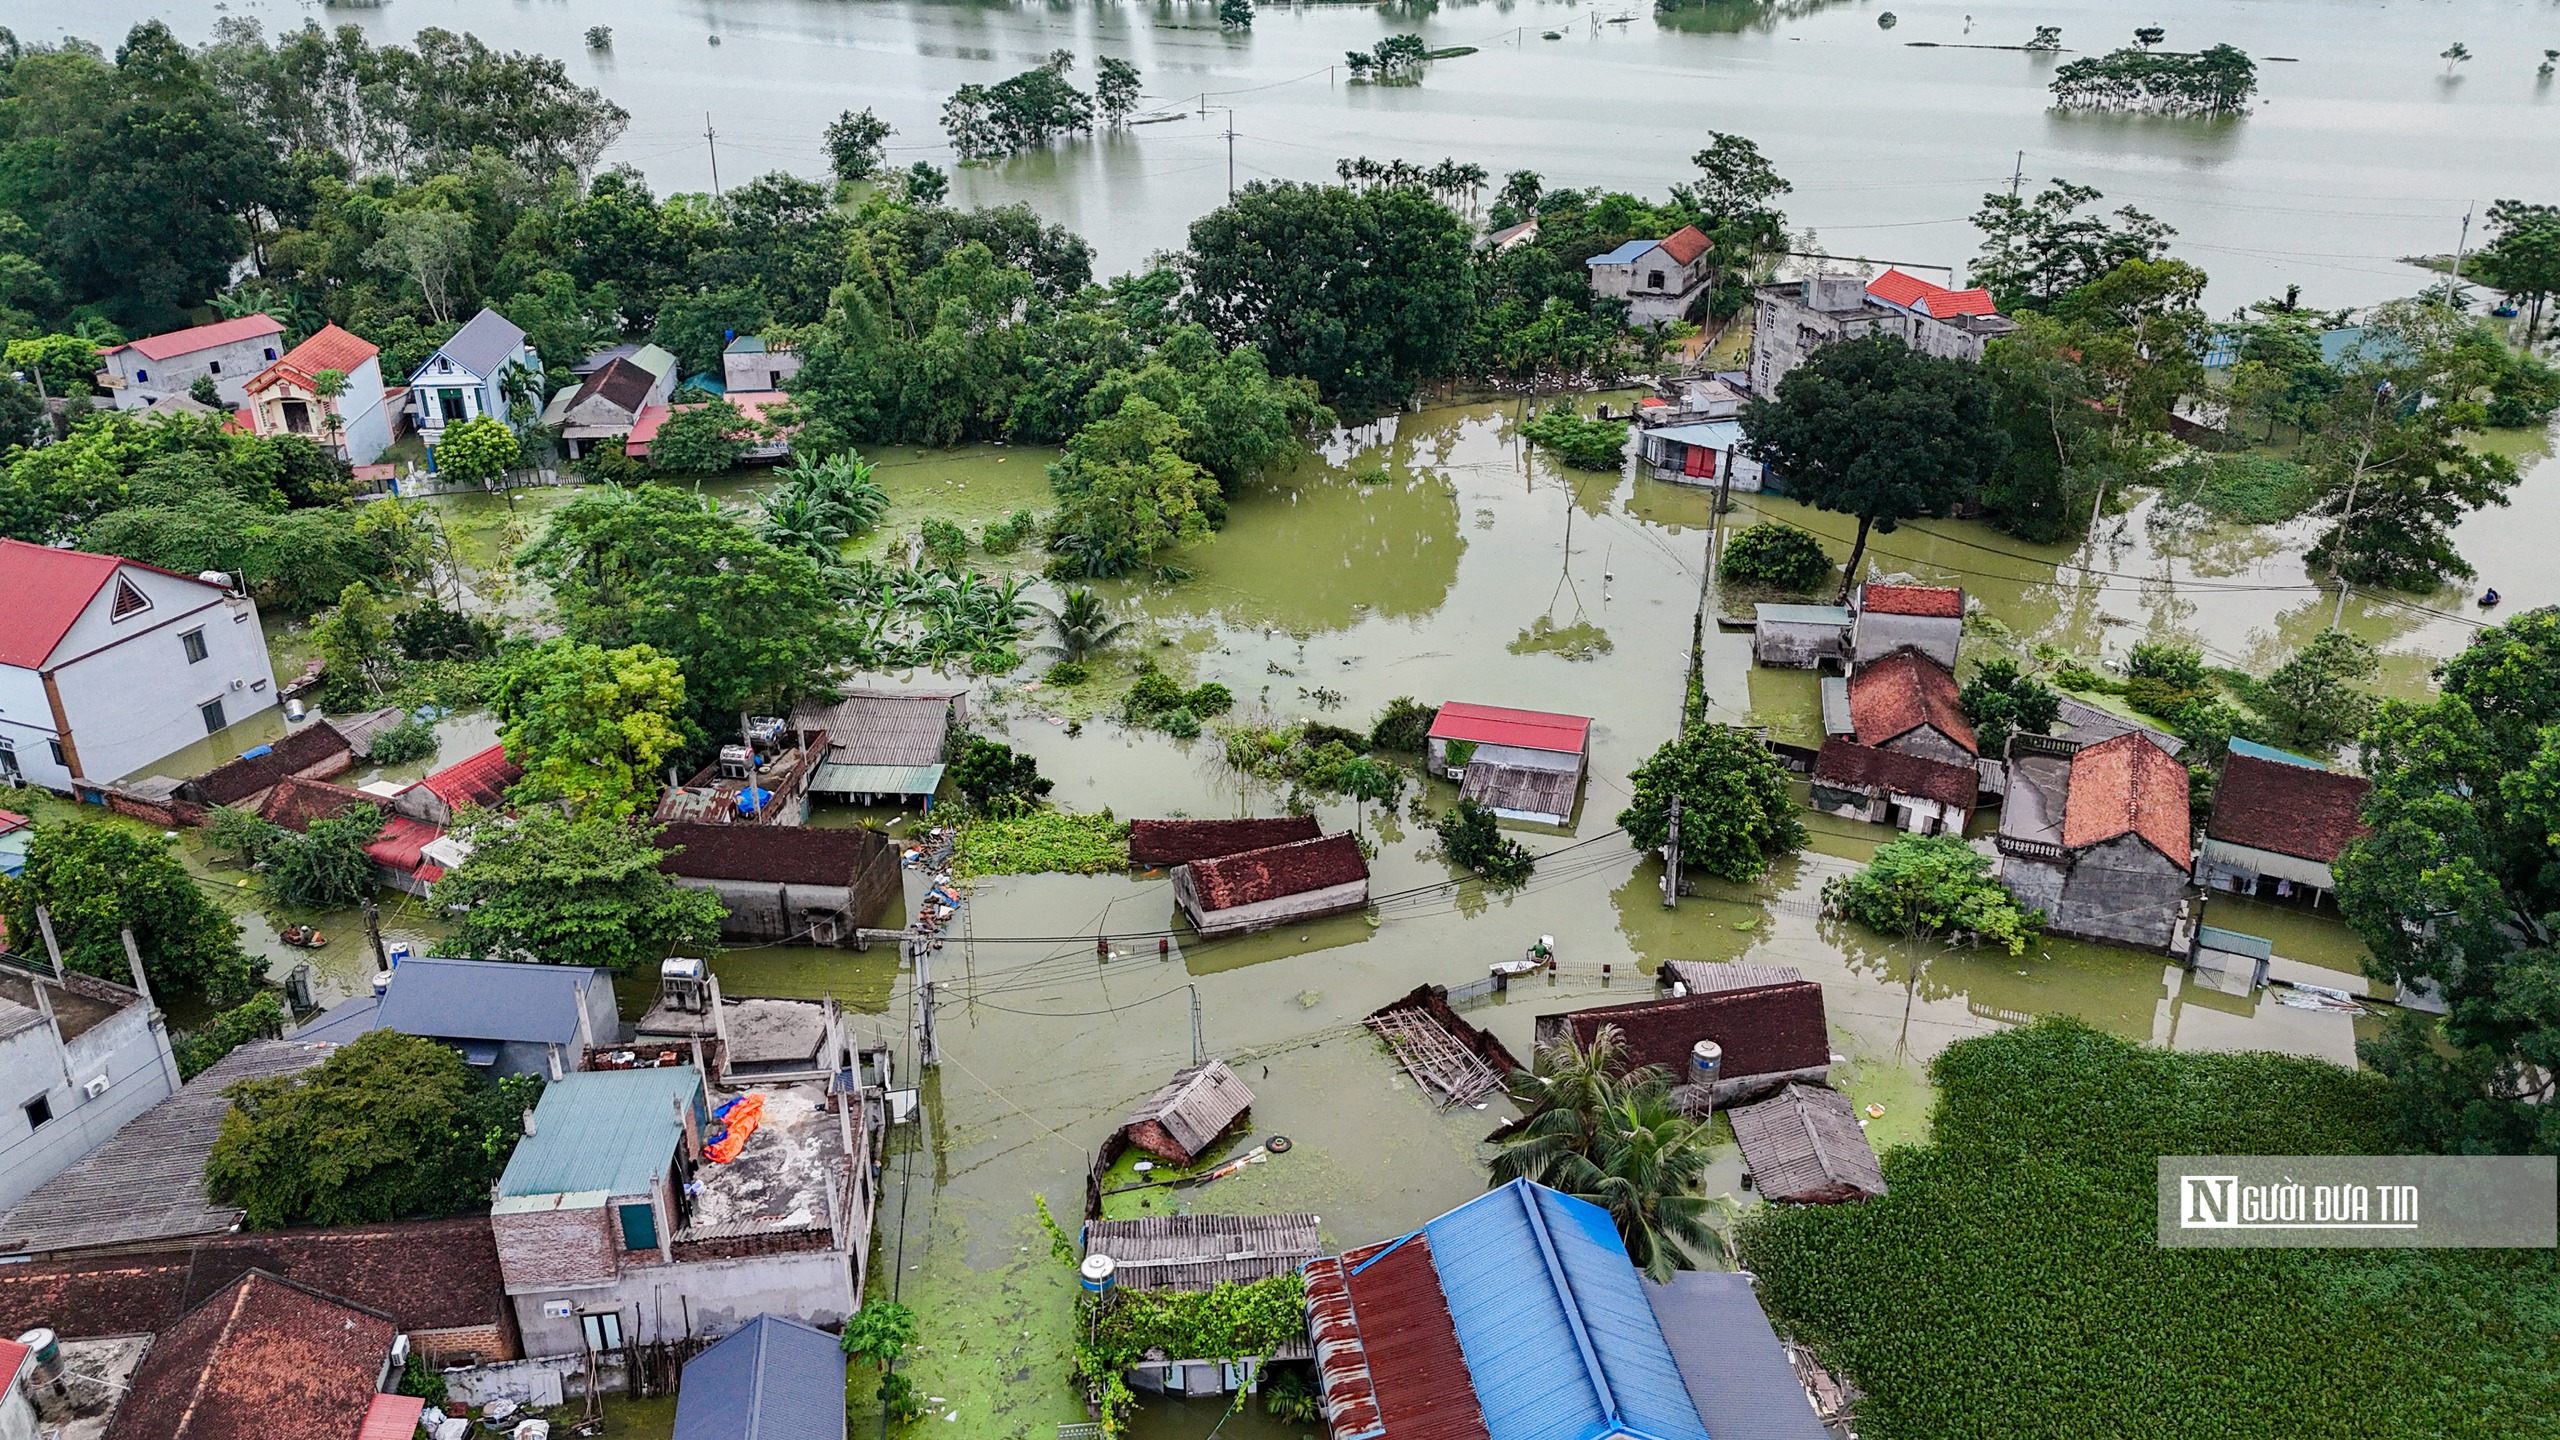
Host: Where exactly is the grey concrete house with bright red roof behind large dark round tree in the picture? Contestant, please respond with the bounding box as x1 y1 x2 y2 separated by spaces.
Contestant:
1751 269 2017 395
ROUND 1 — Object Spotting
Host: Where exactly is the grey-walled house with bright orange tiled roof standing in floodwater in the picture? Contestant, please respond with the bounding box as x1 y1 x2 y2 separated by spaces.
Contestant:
1997 733 2194 953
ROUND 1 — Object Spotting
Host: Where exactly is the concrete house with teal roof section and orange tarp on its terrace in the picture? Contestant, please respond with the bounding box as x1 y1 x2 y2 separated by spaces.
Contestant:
489 1066 878 1355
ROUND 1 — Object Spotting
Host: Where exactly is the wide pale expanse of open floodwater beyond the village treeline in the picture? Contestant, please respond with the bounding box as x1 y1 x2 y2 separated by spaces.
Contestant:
35 0 2560 310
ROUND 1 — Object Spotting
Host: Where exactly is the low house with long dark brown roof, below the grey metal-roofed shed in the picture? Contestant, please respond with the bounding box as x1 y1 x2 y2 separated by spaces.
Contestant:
658 822 899 945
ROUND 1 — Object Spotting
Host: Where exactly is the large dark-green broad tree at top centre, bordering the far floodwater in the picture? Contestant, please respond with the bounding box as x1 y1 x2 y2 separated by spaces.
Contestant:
1180 182 1475 405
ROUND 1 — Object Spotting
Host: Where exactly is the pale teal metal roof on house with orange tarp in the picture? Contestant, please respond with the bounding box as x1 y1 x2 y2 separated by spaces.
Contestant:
497 1066 701 1197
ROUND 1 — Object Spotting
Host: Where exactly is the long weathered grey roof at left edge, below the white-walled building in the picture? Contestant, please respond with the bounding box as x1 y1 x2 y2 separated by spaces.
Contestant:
0 1038 335 1256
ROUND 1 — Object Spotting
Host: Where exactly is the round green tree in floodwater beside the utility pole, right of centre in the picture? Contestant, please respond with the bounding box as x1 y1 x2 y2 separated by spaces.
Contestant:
1618 725 1805 881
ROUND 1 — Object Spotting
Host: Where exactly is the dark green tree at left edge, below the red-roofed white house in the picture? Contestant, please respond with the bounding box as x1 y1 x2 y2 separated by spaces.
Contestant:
0 820 261 1004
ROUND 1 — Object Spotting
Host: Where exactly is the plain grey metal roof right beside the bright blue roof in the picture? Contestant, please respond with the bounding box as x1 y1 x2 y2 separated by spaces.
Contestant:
1644 1271 1830 1440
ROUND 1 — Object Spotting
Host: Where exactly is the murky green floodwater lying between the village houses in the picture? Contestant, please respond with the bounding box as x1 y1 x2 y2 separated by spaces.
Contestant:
80 389 2560 1440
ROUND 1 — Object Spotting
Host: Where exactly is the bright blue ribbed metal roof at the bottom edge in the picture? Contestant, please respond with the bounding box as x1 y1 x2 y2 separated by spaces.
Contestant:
1423 1181 1708 1440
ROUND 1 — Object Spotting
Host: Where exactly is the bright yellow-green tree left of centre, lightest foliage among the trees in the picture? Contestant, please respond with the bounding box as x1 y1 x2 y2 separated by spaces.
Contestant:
489 638 684 820
